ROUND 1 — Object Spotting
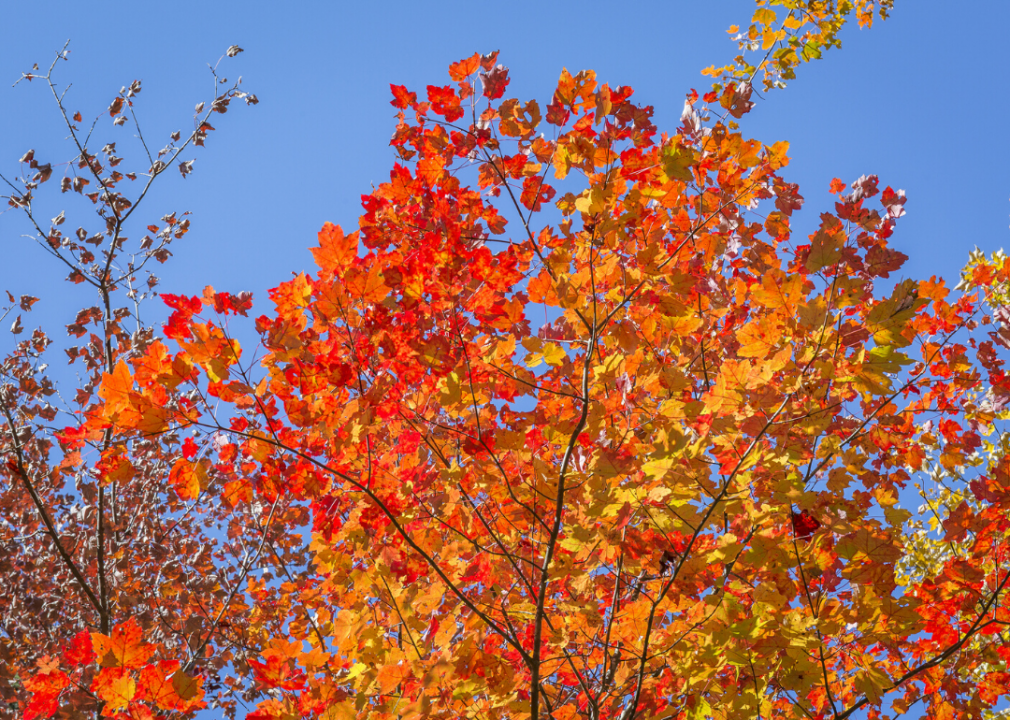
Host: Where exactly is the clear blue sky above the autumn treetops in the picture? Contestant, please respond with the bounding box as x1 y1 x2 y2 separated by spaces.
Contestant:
0 0 1010 333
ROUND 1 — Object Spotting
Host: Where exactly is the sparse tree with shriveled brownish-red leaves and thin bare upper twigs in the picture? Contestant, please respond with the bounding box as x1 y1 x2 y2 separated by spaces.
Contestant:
0 46 292 718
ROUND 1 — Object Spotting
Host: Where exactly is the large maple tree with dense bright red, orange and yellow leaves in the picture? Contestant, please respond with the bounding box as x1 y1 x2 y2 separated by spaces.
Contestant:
17 0 1010 720
